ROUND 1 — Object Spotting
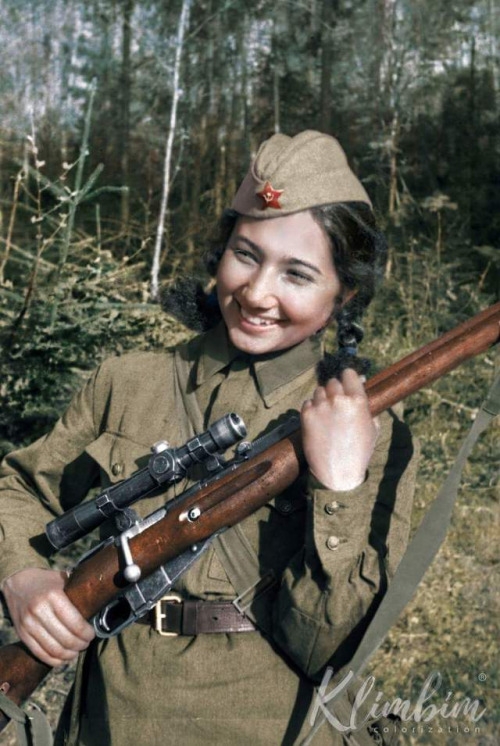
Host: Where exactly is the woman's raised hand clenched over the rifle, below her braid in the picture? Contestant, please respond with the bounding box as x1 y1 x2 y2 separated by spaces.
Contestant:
301 368 379 491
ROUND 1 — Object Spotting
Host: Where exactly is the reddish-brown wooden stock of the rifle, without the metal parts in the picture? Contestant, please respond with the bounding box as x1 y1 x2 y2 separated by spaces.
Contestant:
0 303 500 732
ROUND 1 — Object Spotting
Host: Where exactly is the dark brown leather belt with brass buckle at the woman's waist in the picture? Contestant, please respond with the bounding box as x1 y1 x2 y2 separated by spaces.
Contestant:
136 593 257 637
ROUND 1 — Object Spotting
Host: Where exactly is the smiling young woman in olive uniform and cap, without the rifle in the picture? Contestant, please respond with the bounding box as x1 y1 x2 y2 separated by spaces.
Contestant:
0 131 414 746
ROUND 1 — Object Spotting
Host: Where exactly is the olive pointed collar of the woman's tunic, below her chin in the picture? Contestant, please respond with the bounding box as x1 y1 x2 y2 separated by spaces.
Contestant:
196 322 322 398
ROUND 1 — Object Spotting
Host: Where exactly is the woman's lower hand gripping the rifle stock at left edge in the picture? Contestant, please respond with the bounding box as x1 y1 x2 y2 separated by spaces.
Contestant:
2 568 95 666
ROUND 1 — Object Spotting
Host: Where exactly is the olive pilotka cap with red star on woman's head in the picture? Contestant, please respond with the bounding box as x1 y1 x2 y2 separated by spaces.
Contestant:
231 130 371 218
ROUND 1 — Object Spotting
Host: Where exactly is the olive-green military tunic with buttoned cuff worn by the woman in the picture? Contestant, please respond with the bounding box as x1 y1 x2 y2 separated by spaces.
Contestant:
0 324 415 746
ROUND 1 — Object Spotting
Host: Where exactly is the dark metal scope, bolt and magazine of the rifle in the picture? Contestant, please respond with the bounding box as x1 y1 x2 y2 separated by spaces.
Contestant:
45 406 251 637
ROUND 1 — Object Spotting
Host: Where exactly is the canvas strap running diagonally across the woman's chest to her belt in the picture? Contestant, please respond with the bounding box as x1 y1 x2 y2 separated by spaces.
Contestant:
174 350 275 632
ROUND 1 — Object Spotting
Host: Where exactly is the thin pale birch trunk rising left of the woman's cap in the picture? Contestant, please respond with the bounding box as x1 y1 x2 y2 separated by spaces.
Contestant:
151 0 191 300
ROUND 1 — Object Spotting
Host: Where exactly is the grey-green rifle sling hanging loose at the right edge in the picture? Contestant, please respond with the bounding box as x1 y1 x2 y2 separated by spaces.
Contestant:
302 376 500 746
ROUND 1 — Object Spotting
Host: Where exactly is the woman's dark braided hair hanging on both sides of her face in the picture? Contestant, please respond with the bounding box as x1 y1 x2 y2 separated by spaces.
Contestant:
162 202 387 385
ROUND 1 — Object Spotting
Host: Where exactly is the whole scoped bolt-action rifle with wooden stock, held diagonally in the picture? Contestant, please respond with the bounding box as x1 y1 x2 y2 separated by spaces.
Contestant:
0 303 500 731
